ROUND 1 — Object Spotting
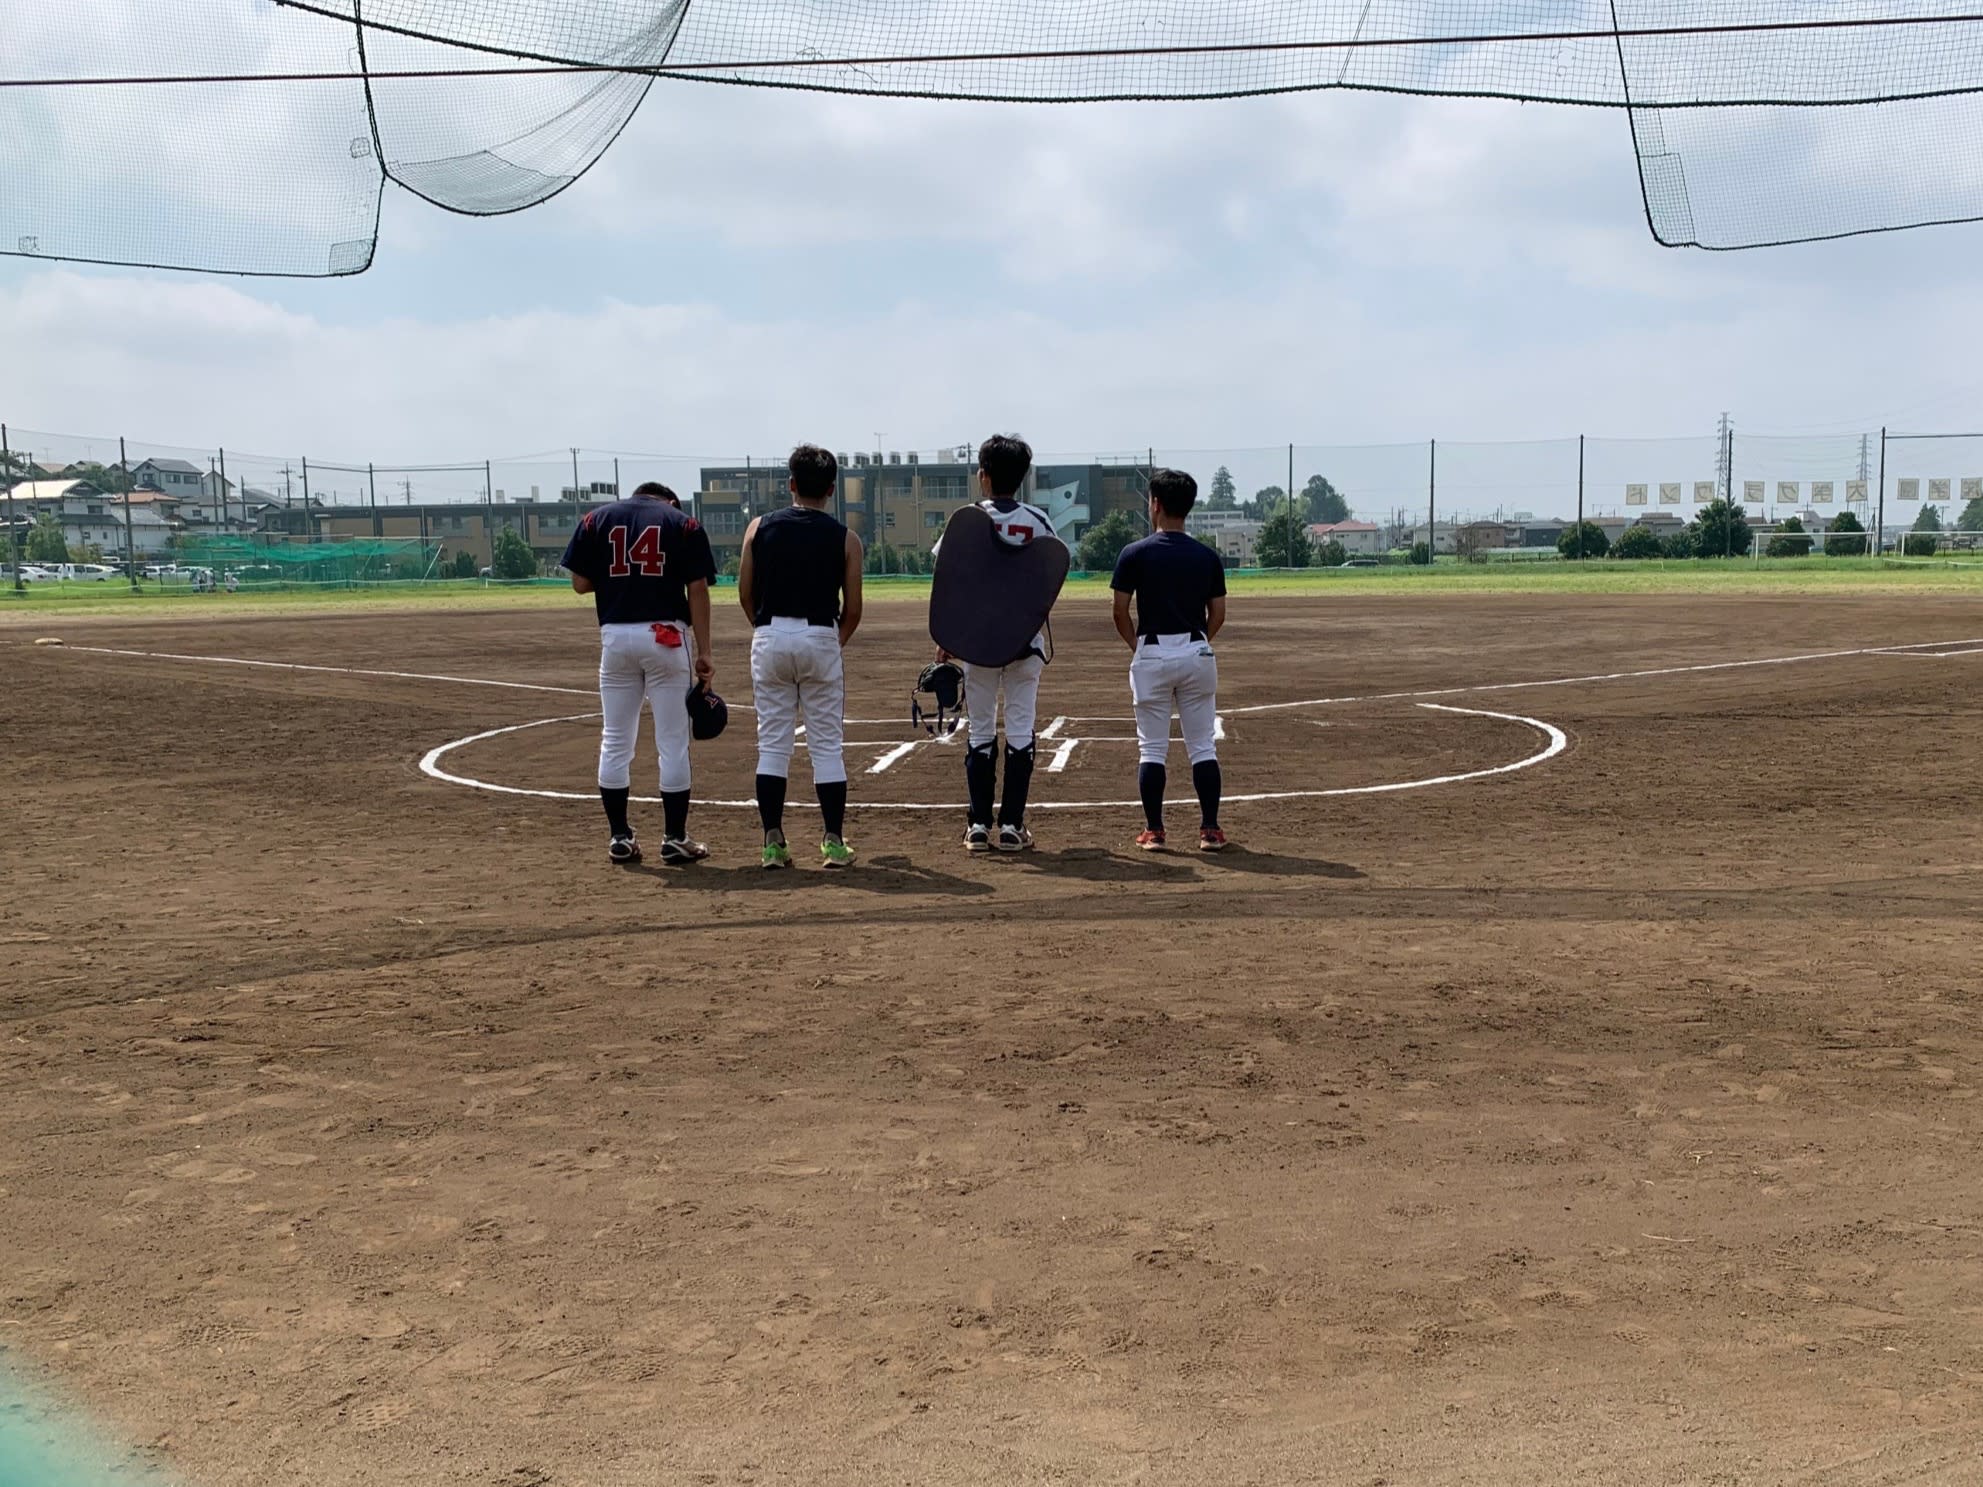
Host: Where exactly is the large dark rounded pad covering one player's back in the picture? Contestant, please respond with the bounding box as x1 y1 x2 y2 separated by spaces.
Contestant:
930 506 1069 666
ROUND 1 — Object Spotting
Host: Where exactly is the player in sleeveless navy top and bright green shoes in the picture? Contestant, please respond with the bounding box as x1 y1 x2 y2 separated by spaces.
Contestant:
738 444 863 868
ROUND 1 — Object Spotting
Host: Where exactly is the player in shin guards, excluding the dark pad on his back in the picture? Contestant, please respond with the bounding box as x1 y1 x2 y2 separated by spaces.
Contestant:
932 434 1055 853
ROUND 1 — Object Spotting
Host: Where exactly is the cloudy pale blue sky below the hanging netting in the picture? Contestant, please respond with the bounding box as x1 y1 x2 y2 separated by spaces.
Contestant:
0 83 1983 515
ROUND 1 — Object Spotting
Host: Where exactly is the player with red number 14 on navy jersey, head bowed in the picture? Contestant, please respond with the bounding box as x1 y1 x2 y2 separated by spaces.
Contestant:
563 484 716 862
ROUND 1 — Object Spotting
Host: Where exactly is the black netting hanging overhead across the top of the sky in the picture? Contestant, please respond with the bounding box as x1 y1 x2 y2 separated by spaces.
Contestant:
11 0 1983 276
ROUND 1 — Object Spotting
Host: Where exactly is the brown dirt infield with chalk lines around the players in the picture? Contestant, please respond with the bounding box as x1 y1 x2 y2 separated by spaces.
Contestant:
0 595 1983 1487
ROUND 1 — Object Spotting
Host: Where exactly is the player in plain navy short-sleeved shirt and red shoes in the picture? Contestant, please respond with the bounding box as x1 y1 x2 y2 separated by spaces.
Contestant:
1108 470 1225 853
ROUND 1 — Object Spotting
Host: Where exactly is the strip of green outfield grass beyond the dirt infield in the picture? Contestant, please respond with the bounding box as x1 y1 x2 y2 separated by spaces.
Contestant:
0 557 1983 625
